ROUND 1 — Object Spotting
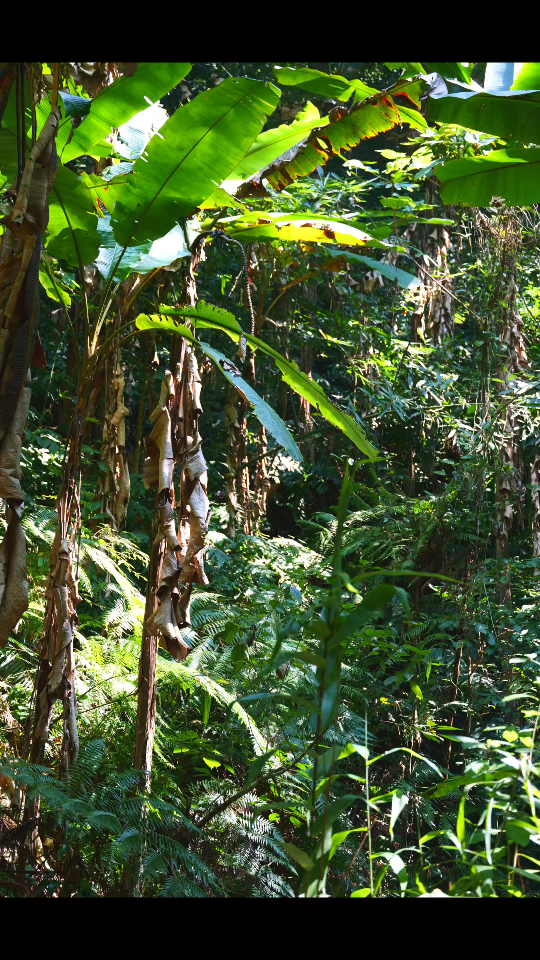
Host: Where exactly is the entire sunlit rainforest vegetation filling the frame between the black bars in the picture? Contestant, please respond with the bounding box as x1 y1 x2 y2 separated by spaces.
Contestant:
0 62 540 899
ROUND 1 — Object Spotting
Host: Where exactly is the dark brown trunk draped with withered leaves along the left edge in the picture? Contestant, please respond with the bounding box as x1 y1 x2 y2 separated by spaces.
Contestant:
0 75 60 647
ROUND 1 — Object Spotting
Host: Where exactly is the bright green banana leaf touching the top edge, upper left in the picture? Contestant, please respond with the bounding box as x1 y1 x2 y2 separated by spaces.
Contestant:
61 63 191 163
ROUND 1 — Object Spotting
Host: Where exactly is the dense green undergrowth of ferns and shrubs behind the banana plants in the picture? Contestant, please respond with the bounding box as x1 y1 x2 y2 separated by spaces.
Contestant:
0 64 540 898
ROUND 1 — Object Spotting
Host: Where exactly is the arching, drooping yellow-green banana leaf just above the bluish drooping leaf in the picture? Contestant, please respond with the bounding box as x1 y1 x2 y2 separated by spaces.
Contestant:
135 301 377 460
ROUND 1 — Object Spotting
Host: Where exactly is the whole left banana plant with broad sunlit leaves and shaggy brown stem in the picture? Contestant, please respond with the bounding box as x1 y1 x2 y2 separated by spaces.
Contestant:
0 63 422 784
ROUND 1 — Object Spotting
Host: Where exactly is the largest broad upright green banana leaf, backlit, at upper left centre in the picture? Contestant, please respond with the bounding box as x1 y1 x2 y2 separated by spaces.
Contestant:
113 77 279 246
